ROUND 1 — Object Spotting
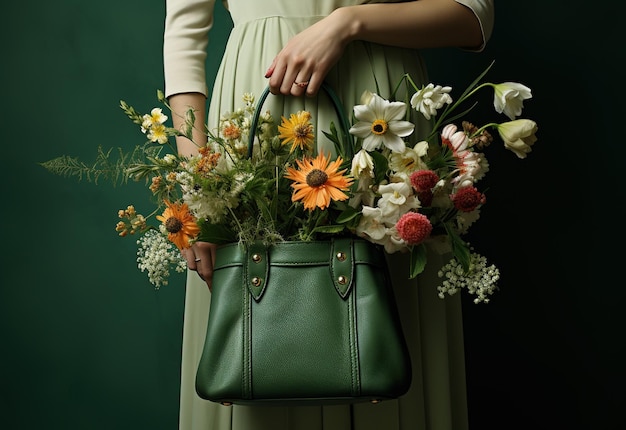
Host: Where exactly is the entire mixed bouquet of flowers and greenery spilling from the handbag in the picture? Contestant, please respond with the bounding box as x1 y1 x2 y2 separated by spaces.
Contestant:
42 61 537 303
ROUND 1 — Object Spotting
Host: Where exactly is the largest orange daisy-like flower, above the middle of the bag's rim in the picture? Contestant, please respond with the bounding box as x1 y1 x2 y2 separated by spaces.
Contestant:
285 154 353 210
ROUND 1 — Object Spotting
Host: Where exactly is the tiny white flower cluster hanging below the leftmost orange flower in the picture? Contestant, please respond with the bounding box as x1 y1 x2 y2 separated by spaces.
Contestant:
137 230 187 290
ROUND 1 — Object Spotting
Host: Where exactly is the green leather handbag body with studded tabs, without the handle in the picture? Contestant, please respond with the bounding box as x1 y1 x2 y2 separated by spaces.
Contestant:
196 238 411 405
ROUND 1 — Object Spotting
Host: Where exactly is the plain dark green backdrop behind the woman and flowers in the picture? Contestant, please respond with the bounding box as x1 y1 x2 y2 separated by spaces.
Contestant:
0 0 625 430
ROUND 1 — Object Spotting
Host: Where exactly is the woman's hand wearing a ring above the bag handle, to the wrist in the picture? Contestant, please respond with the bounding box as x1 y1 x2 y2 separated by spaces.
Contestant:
265 9 351 96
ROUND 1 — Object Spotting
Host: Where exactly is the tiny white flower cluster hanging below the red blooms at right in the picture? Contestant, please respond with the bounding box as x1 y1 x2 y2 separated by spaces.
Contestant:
437 252 500 303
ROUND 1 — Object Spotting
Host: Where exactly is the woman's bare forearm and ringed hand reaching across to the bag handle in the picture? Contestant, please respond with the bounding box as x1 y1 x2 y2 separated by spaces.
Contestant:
265 0 485 96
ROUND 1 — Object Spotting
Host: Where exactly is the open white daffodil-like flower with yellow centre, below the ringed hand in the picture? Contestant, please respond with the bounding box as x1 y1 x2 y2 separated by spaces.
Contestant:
350 93 415 152
